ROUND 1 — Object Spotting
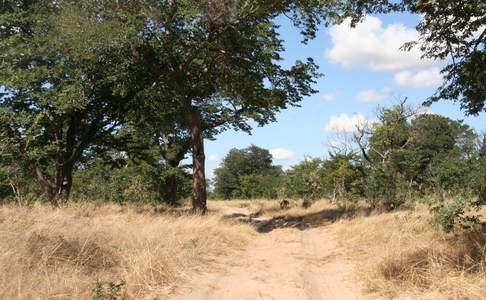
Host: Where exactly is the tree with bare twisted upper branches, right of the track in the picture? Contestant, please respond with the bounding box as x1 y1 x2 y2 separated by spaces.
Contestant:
354 99 420 209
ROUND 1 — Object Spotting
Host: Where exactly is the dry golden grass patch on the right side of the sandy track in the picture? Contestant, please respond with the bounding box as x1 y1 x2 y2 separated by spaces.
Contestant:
335 208 486 299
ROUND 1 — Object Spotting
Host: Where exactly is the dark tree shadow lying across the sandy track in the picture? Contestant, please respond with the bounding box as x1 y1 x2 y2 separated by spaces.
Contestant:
225 207 373 233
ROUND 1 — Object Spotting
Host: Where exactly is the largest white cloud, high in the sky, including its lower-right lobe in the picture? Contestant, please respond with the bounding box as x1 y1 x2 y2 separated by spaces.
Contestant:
326 16 442 87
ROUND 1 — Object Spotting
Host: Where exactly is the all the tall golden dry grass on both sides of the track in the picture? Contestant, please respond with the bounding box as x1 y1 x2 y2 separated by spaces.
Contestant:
0 199 486 299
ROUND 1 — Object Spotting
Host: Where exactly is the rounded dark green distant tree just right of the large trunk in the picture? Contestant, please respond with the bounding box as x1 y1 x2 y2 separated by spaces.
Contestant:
214 145 282 199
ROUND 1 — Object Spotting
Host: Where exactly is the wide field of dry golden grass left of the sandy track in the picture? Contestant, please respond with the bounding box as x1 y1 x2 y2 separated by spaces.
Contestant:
0 204 253 299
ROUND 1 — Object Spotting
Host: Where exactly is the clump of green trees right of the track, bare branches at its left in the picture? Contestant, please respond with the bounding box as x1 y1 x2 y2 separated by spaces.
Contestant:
354 102 480 209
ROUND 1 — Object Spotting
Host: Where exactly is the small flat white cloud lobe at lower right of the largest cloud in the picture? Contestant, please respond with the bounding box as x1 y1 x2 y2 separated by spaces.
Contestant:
394 67 443 87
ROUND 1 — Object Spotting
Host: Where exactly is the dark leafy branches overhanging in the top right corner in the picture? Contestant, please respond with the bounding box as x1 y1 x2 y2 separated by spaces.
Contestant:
405 0 486 115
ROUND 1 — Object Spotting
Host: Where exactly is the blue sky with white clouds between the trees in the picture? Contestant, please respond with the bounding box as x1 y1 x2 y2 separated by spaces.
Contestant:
206 14 486 178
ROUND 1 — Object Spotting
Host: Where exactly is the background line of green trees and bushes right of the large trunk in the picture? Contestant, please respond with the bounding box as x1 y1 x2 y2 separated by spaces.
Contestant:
214 102 486 230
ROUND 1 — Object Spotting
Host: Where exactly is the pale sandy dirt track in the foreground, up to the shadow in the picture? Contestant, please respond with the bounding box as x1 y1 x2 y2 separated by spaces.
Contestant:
168 209 365 300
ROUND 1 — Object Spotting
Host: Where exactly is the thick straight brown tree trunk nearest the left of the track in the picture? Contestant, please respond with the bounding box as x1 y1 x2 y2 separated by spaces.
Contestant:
187 107 207 214
